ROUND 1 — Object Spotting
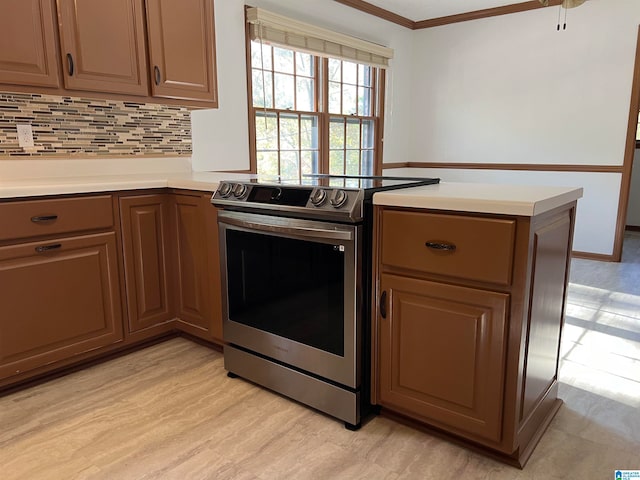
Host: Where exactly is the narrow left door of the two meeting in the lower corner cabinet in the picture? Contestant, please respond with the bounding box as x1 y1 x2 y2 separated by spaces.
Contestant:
120 195 174 332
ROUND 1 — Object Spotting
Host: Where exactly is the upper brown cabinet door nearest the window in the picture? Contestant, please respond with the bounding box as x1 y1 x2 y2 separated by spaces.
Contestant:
146 0 217 106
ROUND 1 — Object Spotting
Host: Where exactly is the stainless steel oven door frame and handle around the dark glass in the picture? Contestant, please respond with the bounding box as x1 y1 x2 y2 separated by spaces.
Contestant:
218 211 363 388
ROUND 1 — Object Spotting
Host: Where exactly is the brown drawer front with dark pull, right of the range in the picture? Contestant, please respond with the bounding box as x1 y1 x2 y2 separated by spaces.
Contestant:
382 210 516 285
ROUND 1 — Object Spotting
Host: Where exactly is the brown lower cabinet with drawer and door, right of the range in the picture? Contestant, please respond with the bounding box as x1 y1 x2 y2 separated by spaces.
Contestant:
371 202 576 466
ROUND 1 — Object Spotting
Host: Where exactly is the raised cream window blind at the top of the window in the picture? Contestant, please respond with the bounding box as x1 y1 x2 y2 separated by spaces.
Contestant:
247 7 393 68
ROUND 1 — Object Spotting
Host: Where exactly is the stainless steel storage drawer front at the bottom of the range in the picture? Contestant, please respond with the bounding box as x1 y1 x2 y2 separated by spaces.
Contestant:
224 345 360 425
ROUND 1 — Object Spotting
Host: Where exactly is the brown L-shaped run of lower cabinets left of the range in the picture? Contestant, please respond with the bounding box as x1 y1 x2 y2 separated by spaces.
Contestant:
0 189 222 388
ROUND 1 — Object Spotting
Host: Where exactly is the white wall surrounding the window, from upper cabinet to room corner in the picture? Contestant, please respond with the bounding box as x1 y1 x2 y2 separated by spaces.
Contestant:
191 0 413 171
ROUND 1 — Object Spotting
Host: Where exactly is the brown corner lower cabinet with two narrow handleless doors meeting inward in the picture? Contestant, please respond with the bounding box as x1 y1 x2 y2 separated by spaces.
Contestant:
119 190 222 342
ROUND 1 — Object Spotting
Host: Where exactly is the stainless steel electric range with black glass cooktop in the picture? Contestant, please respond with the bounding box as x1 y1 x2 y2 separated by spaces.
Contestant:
211 175 439 429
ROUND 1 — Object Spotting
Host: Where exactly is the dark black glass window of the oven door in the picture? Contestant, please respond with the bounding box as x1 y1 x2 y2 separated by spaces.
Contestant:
226 230 344 356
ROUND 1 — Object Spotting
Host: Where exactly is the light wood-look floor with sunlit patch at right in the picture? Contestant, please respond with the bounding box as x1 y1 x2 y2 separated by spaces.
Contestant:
0 235 640 480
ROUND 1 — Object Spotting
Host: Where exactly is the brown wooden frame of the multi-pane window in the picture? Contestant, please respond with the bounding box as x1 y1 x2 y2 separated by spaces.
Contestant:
245 18 386 175
